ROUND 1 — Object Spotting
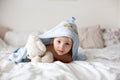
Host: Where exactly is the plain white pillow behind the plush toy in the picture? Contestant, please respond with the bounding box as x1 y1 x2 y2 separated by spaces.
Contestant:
4 31 40 47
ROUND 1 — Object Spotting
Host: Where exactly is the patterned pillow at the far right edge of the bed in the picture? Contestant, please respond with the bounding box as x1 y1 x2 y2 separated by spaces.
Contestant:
103 28 120 47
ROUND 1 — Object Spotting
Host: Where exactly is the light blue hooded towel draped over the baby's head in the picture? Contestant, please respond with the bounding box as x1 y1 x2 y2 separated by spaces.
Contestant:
39 17 79 60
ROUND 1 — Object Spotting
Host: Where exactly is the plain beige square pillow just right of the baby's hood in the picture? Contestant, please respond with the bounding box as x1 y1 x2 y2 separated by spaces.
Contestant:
78 25 104 48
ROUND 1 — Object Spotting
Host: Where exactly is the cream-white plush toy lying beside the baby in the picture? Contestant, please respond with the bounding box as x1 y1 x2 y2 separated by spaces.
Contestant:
25 34 54 63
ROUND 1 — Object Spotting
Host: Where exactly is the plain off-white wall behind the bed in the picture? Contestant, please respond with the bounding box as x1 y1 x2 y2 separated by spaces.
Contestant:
0 0 120 31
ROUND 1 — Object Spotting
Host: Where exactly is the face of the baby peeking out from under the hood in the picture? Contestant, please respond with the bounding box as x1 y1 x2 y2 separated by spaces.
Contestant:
53 37 72 55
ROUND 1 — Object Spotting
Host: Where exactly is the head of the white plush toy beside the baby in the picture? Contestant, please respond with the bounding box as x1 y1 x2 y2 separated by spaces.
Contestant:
25 35 46 59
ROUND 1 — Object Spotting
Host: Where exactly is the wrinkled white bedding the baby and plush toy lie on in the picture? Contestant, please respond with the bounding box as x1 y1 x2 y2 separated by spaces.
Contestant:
0 40 120 80
